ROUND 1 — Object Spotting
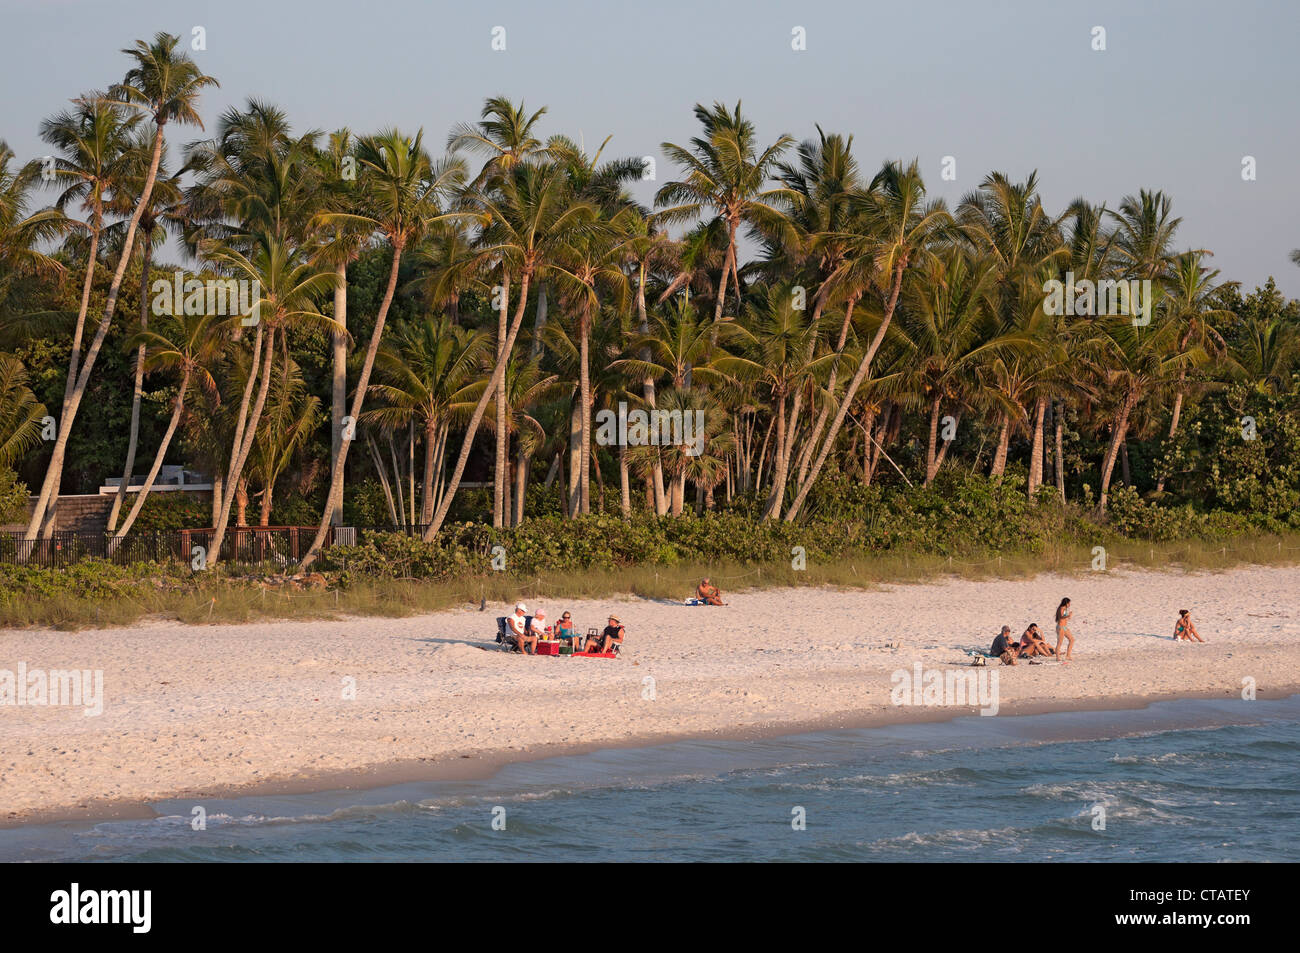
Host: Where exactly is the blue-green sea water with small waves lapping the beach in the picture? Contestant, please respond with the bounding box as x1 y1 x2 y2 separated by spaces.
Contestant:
0 696 1300 862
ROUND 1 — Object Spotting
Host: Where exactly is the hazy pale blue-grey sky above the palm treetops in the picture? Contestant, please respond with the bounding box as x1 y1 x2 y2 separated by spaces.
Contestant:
0 0 1300 296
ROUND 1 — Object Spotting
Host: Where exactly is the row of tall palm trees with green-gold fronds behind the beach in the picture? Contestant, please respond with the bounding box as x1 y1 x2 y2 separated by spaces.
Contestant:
0 34 1296 568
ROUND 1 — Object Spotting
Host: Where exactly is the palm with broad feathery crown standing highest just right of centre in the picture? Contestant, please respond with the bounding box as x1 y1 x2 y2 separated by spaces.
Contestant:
655 103 796 321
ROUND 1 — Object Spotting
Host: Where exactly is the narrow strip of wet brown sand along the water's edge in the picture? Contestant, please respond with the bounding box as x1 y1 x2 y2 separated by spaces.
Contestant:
0 683 1300 831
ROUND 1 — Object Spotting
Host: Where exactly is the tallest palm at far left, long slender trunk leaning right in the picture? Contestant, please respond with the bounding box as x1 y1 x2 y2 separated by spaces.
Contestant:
23 33 218 549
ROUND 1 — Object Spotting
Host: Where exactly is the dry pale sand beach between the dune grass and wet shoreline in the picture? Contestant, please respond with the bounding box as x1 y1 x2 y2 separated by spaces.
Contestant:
0 567 1300 824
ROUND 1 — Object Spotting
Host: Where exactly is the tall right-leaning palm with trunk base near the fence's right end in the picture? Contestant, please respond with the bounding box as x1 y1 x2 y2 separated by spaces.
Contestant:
299 129 465 572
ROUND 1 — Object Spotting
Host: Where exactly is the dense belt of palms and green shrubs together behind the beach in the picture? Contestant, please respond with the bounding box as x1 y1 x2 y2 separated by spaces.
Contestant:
0 34 1300 579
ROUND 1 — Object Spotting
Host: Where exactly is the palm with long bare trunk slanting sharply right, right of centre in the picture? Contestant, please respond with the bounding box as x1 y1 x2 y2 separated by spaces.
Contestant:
785 160 953 523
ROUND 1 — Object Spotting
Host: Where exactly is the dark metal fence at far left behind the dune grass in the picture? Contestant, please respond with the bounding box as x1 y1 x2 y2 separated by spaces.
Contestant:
0 527 364 569
